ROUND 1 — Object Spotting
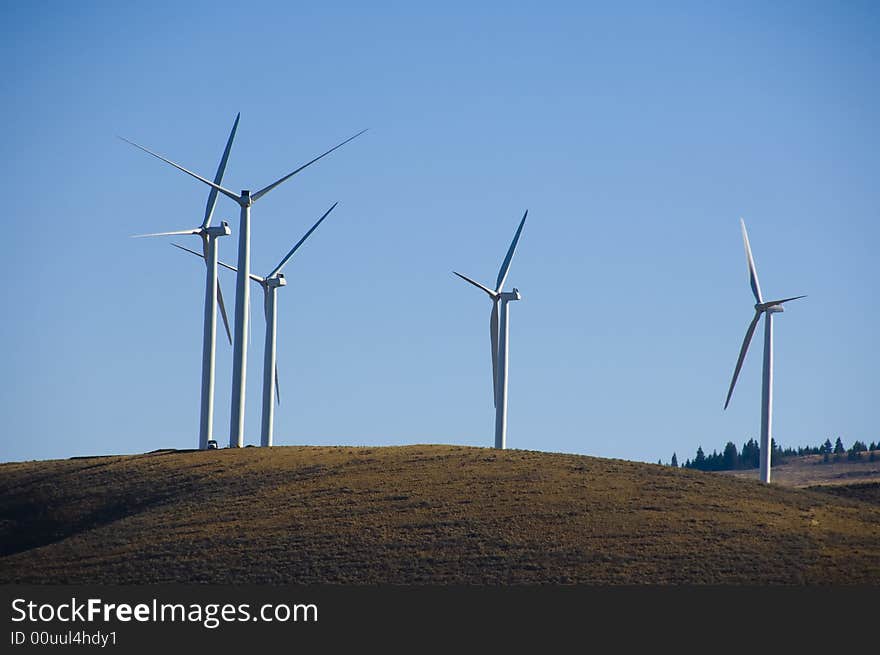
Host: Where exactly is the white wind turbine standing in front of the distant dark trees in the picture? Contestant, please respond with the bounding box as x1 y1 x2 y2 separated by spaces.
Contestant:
724 219 806 484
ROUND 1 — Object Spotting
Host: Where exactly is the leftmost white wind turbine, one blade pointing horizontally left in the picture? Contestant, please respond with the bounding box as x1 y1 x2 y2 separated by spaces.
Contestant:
129 114 241 450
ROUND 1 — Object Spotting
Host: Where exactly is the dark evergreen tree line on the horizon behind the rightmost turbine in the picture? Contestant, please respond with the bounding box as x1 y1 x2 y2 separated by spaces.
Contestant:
657 437 880 471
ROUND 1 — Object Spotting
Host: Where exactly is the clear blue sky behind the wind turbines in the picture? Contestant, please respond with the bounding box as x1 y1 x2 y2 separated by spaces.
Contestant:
0 1 880 461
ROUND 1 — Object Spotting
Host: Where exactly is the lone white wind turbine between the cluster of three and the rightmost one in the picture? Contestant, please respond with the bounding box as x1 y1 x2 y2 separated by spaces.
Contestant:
452 209 529 450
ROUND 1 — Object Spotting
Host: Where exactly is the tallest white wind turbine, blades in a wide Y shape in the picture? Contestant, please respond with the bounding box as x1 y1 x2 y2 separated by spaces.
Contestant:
120 125 366 448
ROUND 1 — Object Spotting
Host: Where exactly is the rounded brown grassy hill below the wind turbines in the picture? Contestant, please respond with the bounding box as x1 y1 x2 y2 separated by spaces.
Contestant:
0 446 880 584
